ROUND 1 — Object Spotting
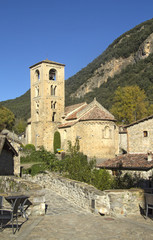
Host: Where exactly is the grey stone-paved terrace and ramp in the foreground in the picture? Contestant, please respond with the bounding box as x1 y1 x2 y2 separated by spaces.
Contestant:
0 190 153 240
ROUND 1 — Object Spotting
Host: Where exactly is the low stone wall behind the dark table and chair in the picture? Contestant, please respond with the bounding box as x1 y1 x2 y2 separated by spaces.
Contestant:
0 176 45 215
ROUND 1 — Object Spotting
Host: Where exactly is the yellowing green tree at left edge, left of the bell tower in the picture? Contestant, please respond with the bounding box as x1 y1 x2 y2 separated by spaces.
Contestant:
0 106 15 131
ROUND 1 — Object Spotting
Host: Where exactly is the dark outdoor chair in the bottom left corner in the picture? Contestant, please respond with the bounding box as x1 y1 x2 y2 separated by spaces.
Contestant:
0 198 20 234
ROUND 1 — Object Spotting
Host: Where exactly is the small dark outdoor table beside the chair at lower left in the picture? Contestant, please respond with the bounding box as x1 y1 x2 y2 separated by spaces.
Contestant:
5 195 29 219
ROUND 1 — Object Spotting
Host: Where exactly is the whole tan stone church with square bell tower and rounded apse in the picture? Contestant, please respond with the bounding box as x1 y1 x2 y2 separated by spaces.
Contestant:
26 59 119 161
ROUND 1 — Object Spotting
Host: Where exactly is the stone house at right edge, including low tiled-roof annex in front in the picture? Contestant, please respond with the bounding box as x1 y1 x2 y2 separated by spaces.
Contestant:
97 115 153 186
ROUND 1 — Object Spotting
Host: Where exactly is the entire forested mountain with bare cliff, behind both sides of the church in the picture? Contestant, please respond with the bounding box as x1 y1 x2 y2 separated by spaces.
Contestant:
0 19 153 119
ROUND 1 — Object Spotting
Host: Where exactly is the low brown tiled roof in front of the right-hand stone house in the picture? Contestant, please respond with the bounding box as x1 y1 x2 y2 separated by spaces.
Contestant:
97 154 153 170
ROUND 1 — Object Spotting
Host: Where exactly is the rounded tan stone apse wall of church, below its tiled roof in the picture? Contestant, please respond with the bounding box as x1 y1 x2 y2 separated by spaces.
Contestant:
59 120 119 162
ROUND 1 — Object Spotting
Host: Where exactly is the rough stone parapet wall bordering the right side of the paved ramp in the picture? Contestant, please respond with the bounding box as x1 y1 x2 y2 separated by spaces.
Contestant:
24 173 144 216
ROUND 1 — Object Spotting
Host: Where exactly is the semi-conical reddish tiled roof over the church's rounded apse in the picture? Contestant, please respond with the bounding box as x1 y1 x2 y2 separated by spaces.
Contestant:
80 106 115 121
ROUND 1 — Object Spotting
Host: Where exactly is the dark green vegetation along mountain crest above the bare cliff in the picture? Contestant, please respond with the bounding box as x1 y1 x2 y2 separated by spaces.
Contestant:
66 19 153 102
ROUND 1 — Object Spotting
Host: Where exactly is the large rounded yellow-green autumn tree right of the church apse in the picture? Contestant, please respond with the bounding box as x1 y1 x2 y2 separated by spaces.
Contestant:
110 85 148 124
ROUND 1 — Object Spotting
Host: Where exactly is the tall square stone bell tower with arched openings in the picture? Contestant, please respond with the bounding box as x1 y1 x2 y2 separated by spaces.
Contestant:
30 59 65 151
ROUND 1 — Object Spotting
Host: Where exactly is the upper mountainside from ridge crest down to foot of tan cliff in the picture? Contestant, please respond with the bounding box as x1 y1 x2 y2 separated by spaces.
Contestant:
66 19 153 102
